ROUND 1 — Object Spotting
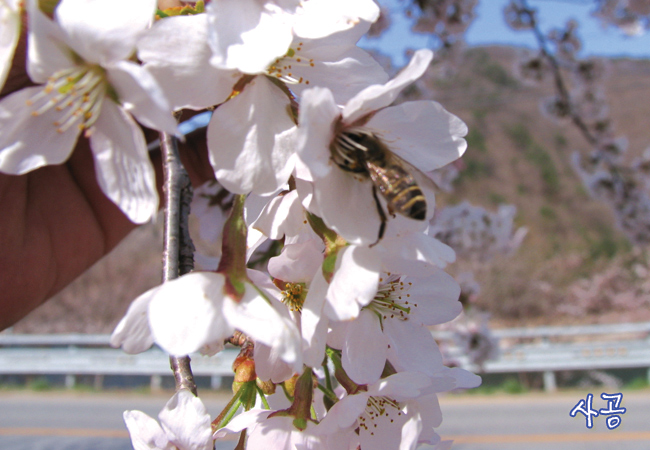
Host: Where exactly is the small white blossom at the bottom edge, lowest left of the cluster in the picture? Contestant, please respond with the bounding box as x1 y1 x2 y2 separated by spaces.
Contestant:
124 389 214 450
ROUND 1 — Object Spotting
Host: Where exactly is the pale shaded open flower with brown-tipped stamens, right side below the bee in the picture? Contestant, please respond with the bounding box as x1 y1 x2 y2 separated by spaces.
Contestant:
328 270 462 384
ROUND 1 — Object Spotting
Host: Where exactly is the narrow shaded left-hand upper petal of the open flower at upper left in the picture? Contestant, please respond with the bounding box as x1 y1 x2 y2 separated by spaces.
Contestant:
27 0 75 83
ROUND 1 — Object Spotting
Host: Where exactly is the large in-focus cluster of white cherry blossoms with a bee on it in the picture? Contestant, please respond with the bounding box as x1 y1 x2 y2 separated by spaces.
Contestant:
0 0 480 450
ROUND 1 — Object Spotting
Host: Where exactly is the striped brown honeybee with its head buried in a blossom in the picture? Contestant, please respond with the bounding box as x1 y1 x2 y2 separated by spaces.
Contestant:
330 127 433 245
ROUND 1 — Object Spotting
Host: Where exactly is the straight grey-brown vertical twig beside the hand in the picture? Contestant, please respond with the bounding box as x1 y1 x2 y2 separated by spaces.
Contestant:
160 129 197 395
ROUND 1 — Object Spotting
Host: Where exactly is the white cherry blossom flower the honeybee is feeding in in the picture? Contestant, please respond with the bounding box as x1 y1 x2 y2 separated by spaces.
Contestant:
297 50 467 245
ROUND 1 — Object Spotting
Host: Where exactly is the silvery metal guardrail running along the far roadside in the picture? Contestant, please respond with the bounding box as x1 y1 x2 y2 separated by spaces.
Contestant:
0 322 650 391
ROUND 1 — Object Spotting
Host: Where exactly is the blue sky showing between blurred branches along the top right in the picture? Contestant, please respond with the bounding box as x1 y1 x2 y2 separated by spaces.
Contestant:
363 0 650 65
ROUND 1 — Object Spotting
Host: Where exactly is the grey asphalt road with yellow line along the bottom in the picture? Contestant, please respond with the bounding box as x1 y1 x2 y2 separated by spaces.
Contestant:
0 391 650 450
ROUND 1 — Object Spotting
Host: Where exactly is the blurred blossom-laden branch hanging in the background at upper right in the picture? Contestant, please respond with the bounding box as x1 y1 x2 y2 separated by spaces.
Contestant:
505 0 650 243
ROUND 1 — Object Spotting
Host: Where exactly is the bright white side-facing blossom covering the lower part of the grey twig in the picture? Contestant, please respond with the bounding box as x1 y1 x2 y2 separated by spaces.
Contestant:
111 271 302 370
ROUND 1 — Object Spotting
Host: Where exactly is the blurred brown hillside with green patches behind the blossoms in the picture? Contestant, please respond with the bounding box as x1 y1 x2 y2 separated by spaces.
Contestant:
14 47 650 332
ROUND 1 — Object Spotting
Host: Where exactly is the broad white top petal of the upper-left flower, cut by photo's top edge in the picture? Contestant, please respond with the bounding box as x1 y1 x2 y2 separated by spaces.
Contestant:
55 0 156 66
